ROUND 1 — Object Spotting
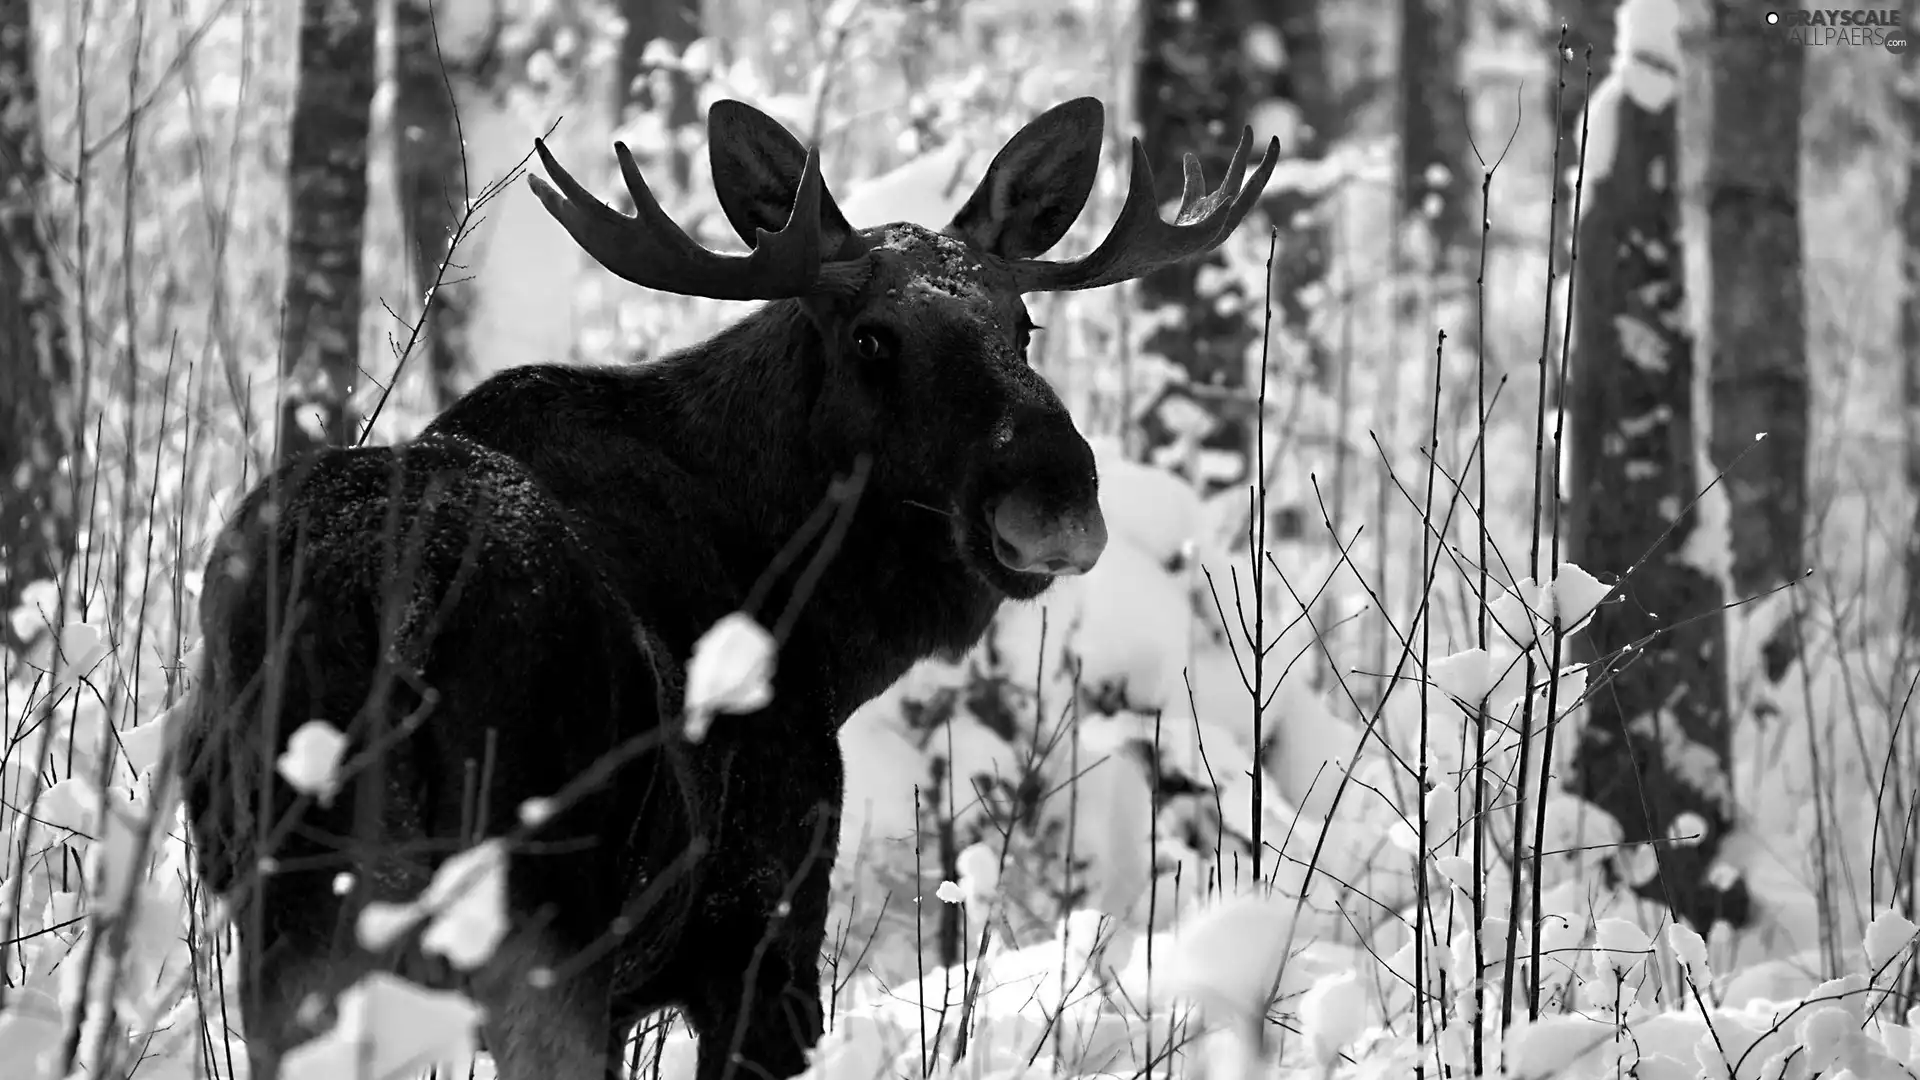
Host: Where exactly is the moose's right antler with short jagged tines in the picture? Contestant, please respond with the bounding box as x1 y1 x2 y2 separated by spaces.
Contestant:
1008 127 1281 292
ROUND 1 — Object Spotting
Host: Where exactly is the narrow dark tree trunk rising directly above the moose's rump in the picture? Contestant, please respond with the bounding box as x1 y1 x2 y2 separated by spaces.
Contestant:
276 0 374 461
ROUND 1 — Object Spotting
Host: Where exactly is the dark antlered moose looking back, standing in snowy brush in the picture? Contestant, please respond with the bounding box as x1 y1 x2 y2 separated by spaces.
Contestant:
173 98 1279 1080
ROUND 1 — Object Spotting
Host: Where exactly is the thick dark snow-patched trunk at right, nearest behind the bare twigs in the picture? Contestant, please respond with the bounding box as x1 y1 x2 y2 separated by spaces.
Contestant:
1565 46 1749 930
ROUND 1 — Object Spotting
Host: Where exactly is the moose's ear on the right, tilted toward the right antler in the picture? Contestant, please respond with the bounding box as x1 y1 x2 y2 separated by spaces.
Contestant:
947 98 1106 259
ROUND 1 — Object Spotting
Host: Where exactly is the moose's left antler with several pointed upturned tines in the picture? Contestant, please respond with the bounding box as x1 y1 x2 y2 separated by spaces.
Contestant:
526 138 822 300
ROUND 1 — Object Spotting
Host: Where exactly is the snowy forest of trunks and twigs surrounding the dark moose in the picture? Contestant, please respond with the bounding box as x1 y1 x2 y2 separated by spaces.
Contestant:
0 0 1920 1078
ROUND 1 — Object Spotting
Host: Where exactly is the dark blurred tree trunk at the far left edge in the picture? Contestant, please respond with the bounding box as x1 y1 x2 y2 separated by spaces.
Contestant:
0 0 75 630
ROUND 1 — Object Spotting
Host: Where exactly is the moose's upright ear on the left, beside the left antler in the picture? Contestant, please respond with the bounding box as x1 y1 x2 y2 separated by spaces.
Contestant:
707 100 852 258
